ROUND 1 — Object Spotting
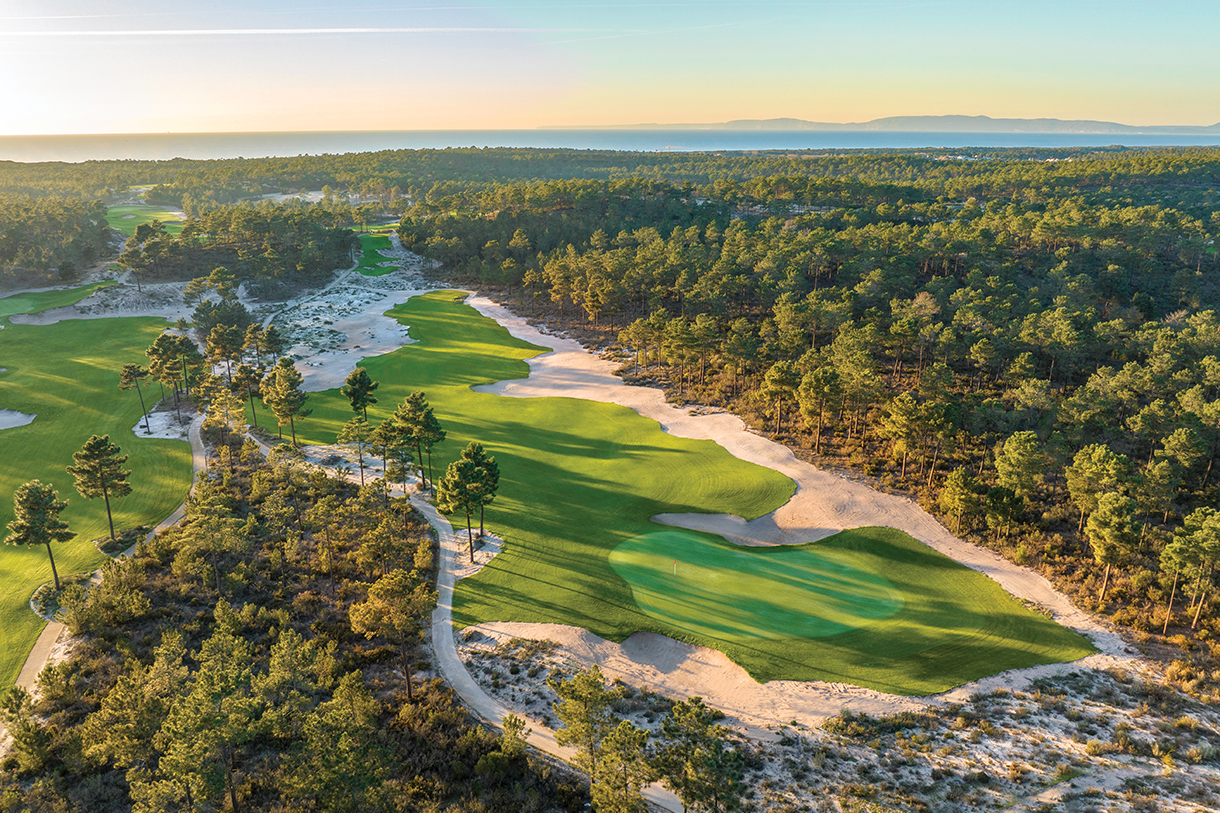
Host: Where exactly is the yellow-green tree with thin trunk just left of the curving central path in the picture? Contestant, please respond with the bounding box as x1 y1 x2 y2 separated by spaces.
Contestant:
350 568 437 699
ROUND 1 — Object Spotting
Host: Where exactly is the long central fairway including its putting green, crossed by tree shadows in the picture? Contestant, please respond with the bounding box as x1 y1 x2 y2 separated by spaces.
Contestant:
298 292 1093 695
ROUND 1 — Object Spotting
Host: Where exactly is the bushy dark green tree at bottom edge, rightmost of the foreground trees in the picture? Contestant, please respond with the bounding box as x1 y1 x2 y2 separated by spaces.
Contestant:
653 697 745 813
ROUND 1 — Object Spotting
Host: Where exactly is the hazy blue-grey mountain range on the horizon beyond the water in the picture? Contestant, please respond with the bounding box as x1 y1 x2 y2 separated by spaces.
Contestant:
539 116 1220 136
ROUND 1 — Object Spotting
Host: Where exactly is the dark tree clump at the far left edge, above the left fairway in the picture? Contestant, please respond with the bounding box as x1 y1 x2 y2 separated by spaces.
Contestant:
0 194 109 286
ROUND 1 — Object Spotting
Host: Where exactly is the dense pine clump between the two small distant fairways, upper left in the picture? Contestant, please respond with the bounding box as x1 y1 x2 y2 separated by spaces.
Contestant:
118 203 359 293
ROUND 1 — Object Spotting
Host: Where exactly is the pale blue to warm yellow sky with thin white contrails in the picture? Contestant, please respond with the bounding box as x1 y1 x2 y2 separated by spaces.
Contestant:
0 0 1220 136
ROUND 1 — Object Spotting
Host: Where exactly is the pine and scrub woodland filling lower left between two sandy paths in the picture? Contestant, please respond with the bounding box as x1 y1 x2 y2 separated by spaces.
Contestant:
0 441 588 813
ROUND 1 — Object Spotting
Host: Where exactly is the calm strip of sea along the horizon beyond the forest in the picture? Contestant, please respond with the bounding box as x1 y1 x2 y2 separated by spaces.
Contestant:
0 129 1220 162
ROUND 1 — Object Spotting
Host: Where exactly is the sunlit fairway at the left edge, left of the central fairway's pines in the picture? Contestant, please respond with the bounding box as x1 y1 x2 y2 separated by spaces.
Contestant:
0 312 192 692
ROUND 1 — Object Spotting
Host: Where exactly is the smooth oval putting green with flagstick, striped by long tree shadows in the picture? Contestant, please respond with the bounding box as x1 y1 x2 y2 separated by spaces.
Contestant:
610 531 904 642
